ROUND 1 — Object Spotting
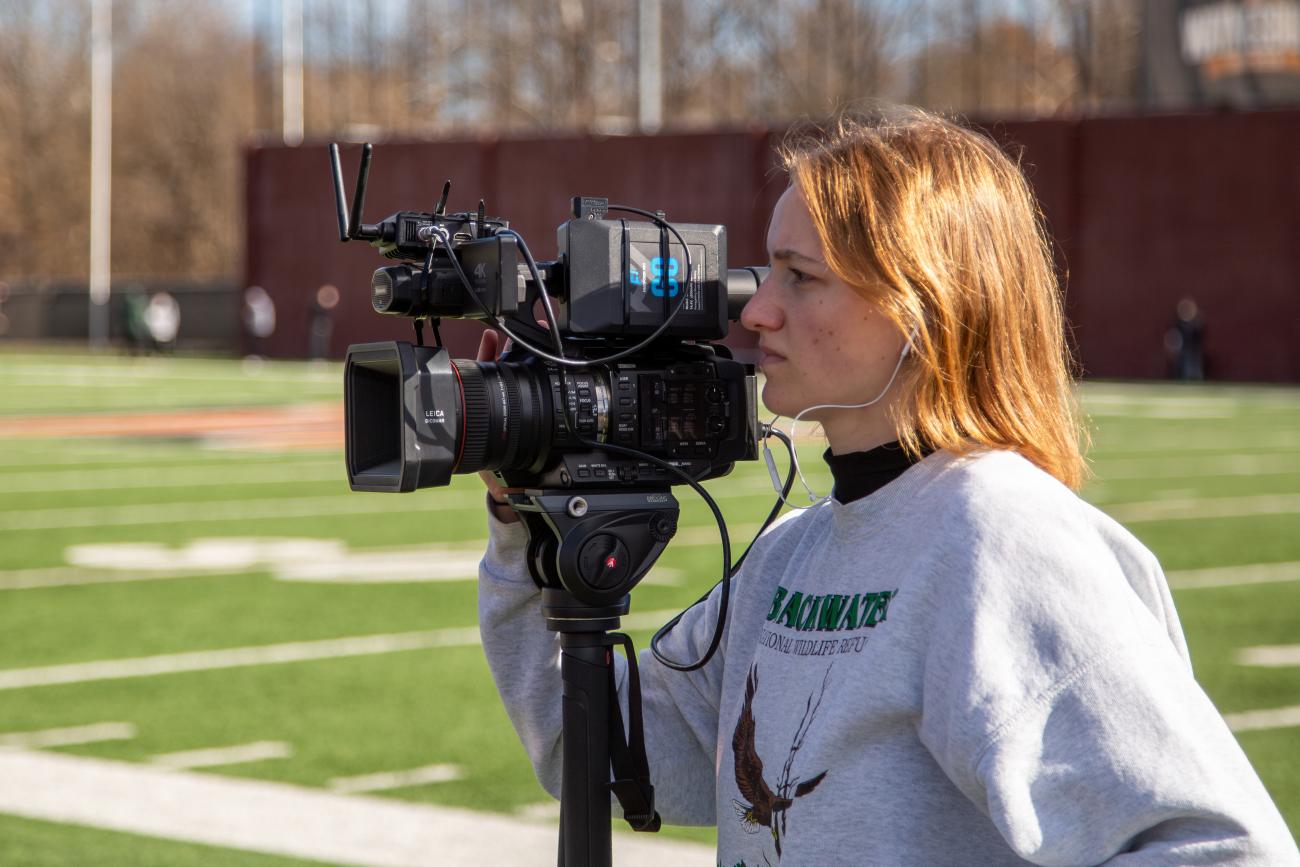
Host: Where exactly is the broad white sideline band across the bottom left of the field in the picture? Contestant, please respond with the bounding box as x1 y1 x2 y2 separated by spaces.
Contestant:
0 751 716 867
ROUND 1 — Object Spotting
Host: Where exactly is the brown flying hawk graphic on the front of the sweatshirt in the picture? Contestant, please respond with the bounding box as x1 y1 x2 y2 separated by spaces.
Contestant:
732 666 831 858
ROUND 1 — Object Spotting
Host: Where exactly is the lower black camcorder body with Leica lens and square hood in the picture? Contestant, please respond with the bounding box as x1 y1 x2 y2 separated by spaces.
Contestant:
345 342 758 491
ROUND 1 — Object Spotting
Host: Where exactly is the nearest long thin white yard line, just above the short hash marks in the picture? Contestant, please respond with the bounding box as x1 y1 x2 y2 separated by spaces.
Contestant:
0 611 677 690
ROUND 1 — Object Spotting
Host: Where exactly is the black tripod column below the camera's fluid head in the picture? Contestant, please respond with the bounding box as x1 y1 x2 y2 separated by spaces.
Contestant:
559 633 614 867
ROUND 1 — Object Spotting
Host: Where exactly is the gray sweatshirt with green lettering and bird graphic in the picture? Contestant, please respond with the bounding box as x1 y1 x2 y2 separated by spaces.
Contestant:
478 451 1300 867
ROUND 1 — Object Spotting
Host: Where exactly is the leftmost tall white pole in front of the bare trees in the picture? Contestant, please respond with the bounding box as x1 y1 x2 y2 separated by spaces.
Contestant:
87 0 113 350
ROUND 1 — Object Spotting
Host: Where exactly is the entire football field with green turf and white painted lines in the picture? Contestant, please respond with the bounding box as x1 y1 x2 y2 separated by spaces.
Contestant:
0 351 1300 867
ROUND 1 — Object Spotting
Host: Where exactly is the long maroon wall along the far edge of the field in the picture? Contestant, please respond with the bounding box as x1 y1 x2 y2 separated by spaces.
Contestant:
247 112 1300 382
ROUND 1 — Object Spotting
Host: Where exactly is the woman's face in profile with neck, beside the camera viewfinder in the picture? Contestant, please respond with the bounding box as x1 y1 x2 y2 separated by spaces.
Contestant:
741 187 905 452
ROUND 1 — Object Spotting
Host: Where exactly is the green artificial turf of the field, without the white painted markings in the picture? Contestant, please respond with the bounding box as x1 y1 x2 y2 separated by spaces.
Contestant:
0 352 1300 867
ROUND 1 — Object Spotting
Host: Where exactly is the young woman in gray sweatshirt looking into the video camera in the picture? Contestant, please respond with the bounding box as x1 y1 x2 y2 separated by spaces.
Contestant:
480 110 1300 867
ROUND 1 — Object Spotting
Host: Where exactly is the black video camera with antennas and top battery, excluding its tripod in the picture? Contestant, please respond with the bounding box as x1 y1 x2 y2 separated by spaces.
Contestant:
330 144 763 501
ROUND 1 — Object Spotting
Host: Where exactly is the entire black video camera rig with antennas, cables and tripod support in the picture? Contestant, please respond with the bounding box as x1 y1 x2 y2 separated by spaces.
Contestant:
330 144 792 867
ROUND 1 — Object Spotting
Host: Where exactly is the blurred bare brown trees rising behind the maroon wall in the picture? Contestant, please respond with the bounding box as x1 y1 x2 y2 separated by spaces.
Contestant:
0 0 1140 289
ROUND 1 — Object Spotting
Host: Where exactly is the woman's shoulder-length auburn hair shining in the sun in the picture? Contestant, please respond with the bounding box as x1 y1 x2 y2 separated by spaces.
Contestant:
779 108 1087 490
